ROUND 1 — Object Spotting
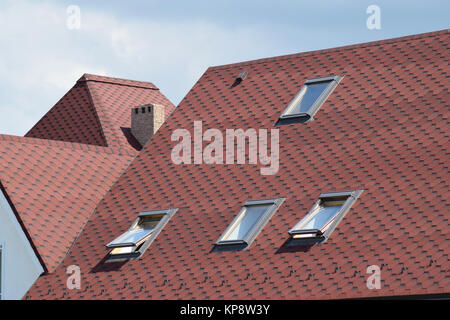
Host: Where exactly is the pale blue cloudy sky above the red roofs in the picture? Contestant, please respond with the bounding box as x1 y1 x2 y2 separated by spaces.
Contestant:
0 0 450 135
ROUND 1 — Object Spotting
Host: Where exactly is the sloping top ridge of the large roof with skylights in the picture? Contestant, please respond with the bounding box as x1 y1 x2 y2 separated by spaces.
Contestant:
208 29 450 70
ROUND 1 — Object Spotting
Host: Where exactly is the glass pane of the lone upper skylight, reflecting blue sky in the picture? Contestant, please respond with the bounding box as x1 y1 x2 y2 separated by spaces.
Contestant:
286 81 331 115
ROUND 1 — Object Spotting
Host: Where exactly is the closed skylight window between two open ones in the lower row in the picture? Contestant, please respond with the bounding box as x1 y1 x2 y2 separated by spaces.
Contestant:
216 199 284 247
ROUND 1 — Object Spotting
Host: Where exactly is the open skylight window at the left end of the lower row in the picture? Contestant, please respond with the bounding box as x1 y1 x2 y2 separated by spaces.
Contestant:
106 209 178 257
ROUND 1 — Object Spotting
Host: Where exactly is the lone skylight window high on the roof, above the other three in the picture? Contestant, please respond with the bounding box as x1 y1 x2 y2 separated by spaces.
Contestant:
280 76 342 120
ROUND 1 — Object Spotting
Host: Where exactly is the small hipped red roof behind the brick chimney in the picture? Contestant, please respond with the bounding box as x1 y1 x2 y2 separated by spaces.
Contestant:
25 74 175 150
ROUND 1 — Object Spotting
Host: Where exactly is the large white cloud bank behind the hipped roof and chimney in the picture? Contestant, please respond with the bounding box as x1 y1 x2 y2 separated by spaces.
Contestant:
0 0 274 135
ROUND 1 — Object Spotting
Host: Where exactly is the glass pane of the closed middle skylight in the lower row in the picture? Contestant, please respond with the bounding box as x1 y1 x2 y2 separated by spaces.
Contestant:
223 205 270 240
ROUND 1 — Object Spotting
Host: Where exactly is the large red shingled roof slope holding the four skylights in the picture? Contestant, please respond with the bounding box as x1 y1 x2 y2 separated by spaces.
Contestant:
27 30 450 299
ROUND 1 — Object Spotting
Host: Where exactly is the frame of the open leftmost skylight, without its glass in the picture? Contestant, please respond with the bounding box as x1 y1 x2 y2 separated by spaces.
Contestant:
106 209 178 258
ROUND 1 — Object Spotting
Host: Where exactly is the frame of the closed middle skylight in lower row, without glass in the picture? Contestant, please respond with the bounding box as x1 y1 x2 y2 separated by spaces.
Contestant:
215 198 285 249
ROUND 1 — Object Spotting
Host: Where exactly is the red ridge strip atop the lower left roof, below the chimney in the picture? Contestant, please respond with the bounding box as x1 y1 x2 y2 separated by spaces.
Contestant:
0 134 134 156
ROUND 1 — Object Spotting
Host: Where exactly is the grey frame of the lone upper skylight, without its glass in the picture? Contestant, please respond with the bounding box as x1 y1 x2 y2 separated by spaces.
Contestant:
280 75 343 120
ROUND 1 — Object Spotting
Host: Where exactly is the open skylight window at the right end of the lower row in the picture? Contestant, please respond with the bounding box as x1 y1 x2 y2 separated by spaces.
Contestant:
289 190 362 239
